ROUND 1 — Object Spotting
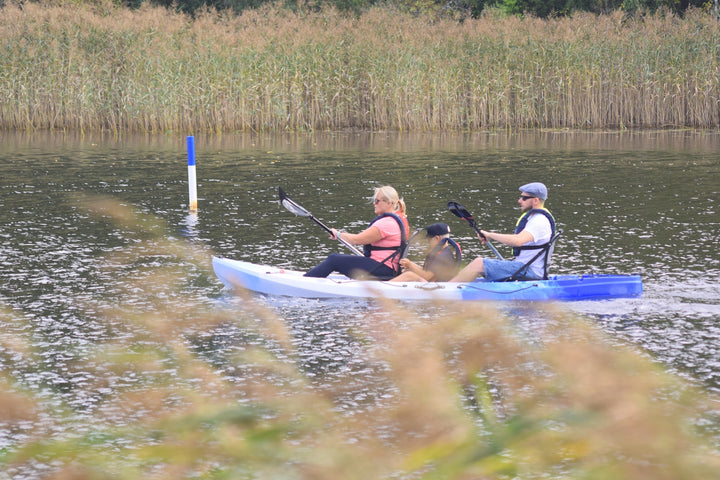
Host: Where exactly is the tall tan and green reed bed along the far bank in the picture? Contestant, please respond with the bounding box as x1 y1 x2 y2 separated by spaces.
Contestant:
0 3 720 132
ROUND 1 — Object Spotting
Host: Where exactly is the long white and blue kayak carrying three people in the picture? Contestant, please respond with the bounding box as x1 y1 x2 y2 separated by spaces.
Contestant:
212 257 643 301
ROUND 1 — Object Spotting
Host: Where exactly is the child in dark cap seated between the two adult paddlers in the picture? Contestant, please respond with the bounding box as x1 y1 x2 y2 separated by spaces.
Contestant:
392 223 462 282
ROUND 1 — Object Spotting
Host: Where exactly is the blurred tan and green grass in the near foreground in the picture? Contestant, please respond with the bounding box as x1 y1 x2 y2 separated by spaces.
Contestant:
0 199 720 480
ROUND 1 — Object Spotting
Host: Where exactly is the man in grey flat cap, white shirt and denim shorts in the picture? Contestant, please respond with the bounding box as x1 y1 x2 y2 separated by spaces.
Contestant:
450 182 555 282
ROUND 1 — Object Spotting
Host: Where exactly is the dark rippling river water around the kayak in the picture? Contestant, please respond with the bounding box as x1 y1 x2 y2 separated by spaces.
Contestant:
0 131 720 462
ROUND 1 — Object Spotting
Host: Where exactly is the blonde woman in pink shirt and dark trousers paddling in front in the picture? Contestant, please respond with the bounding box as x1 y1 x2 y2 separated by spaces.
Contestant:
305 185 410 280
